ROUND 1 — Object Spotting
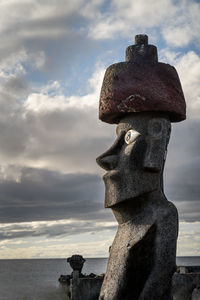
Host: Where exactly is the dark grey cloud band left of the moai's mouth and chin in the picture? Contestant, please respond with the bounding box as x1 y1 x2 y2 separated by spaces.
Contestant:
0 168 113 223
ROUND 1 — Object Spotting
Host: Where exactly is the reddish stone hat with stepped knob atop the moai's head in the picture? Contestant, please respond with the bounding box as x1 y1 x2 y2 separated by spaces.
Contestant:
99 35 186 124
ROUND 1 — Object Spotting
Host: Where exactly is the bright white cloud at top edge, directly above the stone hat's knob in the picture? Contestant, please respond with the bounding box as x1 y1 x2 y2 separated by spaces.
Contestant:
89 0 177 39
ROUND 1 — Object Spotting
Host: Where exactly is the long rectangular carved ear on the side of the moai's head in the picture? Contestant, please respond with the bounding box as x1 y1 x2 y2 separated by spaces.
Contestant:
143 118 171 172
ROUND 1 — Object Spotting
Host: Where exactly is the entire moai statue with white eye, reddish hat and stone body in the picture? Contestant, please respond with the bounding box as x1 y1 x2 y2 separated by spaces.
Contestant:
97 35 186 300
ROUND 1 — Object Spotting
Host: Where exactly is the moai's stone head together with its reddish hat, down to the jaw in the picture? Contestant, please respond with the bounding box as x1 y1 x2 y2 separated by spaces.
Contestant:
97 35 186 207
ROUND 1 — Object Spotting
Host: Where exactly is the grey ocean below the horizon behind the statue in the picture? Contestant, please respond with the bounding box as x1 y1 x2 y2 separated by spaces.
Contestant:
0 256 200 300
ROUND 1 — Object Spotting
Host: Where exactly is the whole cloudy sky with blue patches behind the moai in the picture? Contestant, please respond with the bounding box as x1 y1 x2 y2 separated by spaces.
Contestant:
0 0 200 258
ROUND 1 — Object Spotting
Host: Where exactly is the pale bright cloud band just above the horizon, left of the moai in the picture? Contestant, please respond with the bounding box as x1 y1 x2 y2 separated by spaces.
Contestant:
0 220 116 259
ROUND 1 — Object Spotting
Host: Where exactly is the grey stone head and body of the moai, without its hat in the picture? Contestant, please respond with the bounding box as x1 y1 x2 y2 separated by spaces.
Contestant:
97 113 178 300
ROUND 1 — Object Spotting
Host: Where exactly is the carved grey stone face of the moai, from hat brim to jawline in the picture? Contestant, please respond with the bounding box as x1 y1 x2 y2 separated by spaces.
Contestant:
97 113 171 207
